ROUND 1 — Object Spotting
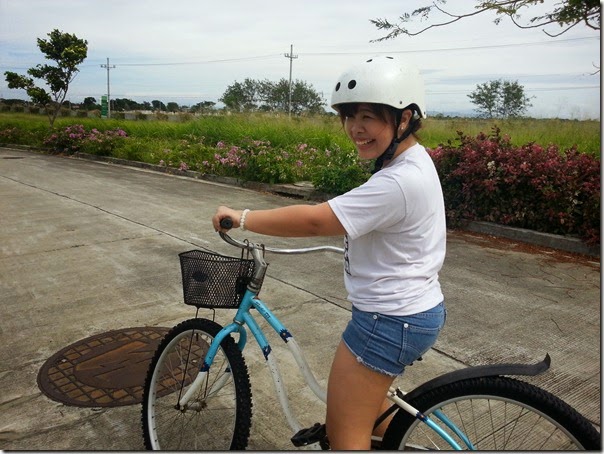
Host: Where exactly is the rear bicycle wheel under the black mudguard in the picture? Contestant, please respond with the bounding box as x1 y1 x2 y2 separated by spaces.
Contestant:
382 377 601 451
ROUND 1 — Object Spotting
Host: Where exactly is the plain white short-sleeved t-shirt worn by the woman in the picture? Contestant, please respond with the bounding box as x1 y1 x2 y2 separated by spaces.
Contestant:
328 144 446 315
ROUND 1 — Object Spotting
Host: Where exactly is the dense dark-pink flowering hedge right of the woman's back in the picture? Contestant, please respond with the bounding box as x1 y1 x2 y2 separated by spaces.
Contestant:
430 128 600 245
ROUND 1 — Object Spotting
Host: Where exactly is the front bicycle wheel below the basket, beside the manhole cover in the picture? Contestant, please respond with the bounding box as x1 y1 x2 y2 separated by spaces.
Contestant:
142 319 252 451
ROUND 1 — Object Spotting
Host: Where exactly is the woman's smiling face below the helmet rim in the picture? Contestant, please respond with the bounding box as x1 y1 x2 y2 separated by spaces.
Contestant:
340 103 396 159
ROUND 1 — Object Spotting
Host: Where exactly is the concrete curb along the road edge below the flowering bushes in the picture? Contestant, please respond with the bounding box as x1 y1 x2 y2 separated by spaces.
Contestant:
5 145 601 258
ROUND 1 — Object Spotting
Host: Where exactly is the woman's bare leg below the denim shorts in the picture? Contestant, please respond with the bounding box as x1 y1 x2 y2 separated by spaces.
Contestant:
326 342 394 450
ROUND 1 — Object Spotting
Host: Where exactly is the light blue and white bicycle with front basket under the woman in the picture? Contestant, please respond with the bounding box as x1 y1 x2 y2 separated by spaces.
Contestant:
141 220 600 451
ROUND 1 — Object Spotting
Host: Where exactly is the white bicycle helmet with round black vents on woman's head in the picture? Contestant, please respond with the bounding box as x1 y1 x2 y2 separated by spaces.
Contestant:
331 56 426 118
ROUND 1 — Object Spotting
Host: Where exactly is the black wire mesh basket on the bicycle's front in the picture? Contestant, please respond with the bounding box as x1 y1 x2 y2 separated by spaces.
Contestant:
178 250 254 309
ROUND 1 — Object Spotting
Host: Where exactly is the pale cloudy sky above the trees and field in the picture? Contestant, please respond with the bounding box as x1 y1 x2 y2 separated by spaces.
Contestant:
0 0 601 120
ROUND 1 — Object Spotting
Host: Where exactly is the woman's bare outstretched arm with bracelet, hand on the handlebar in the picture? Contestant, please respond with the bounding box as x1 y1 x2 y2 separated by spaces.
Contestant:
212 202 346 237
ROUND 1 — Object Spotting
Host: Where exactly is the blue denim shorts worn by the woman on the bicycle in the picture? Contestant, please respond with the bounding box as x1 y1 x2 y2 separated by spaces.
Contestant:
342 302 447 377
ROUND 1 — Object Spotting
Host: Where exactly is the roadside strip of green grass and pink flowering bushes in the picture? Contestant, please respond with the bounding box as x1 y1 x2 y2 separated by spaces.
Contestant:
0 112 600 245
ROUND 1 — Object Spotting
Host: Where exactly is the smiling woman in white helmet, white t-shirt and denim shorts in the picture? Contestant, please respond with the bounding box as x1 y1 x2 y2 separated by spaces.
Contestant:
212 57 446 450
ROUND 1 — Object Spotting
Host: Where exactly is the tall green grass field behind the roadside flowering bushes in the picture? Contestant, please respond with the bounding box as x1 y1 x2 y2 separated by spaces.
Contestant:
0 112 601 156
